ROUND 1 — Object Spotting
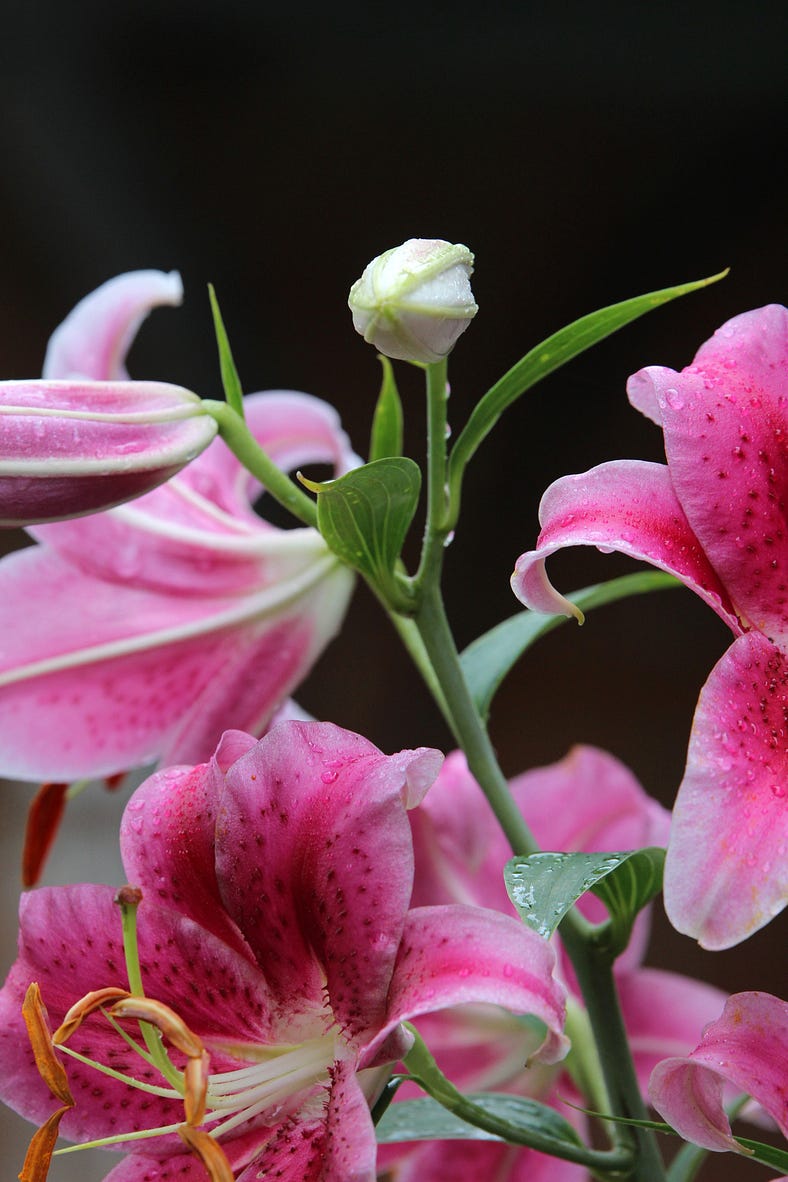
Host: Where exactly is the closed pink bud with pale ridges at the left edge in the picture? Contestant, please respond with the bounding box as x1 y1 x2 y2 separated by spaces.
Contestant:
0 379 216 526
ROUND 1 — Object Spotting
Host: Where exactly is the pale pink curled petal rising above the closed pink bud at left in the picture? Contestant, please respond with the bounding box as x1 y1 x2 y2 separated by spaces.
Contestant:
44 271 183 379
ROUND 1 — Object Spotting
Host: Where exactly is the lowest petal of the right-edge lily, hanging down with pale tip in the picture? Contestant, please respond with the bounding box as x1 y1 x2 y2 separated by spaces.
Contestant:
665 632 788 948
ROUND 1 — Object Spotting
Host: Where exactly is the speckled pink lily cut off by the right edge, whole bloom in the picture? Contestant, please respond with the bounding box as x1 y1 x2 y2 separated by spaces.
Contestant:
512 305 788 948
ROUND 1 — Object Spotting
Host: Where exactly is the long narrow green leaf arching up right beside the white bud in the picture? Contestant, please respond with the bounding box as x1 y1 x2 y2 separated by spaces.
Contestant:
449 269 728 489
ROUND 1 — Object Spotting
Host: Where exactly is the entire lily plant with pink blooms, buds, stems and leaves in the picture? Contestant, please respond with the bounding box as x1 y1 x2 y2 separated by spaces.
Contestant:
0 239 788 1182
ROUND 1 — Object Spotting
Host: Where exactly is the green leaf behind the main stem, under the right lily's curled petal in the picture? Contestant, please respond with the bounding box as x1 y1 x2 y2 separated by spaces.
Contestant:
460 571 682 719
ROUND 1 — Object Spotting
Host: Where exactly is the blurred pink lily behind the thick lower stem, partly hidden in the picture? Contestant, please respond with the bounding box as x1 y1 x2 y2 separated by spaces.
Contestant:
383 747 723 1182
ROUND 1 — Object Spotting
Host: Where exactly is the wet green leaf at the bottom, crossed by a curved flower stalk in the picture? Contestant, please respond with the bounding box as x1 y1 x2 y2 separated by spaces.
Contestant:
376 1092 581 1145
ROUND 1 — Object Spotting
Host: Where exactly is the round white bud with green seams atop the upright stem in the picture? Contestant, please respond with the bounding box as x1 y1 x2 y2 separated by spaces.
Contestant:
347 238 478 364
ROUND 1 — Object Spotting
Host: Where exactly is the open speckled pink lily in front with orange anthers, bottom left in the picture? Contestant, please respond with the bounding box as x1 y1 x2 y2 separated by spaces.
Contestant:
0 722 565 1182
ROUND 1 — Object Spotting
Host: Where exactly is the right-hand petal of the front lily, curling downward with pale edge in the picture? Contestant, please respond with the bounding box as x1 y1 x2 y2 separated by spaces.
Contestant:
379 904 568 1063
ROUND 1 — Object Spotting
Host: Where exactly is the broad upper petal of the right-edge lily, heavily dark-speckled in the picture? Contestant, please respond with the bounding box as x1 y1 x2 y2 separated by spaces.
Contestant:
629 305 788 648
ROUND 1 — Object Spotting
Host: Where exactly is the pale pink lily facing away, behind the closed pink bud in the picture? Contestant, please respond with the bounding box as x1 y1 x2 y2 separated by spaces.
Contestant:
0 272 356 782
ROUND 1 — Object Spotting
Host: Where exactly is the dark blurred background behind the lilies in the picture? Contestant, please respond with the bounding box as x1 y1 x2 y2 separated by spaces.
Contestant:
0 0 787 1182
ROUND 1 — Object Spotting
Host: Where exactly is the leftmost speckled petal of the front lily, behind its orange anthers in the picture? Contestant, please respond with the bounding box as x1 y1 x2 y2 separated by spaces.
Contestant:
0 884 279 1152
